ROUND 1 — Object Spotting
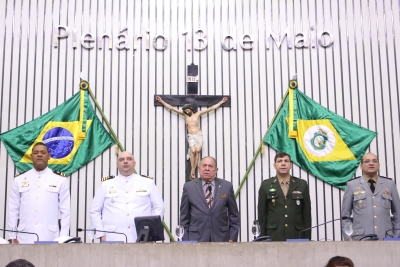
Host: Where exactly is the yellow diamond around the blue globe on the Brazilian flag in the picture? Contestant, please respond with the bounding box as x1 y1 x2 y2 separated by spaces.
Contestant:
20 120 92 164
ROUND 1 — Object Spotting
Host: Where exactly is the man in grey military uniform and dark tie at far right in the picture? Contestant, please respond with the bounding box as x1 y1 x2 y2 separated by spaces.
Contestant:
342 153 400 240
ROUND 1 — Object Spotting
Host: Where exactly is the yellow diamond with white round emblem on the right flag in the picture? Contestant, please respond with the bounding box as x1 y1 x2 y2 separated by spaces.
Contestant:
296 119 356 162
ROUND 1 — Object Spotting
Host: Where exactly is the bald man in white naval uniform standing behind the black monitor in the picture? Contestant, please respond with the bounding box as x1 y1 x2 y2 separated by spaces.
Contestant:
90 151 164 243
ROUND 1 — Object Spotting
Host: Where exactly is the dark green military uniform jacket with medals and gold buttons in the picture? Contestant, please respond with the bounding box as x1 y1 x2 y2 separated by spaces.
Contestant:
258 176 311 241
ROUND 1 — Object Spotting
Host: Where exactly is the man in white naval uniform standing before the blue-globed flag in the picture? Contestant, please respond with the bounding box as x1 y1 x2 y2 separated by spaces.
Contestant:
8 142 71 243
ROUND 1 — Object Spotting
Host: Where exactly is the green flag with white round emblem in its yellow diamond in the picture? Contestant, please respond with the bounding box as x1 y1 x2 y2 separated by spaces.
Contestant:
263 80 376 189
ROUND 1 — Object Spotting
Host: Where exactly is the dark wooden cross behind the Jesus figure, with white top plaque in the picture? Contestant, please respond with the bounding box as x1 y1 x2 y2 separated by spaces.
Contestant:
154 63 231 181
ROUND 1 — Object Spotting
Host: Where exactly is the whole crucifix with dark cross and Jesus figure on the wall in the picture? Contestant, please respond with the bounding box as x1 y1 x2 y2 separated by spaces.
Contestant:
154 63 231 181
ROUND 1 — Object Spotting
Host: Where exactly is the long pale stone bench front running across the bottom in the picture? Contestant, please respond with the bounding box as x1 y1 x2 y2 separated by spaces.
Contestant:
0 241 400 267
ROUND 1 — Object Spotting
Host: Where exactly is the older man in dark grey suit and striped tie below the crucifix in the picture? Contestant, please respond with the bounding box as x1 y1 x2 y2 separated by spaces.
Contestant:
180 157 240 242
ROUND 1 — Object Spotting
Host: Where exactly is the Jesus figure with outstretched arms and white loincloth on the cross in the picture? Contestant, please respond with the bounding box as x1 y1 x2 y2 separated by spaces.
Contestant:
156 96 228 180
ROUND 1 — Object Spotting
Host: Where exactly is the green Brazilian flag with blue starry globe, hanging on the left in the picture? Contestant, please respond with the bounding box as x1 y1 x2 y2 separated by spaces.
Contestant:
0 81 115 178
